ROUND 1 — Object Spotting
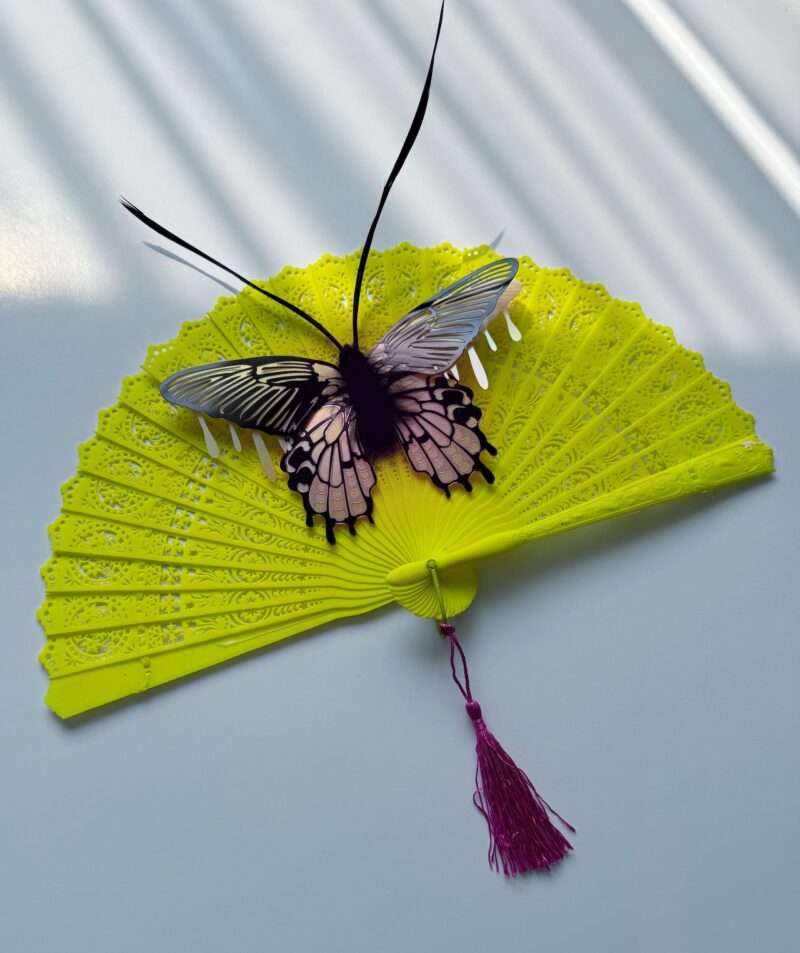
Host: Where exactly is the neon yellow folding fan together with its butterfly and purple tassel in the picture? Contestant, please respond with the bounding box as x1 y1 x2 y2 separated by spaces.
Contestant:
39 1 772 875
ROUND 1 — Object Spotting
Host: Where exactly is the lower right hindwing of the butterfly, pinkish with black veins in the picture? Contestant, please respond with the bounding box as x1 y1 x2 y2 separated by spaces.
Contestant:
389 374 497 496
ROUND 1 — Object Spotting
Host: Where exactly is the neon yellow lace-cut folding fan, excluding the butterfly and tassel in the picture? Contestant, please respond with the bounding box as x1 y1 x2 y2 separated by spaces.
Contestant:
39 238 772 717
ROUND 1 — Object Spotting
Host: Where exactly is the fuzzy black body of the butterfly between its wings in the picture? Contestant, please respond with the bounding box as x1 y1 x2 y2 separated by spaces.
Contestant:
339 344 398 460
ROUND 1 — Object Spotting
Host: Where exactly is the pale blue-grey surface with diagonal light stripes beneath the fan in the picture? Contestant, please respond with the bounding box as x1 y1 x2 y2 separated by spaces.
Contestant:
0 0 800 953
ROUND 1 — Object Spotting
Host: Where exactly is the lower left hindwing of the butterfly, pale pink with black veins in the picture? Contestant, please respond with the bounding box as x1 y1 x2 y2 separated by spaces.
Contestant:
281 395 375 543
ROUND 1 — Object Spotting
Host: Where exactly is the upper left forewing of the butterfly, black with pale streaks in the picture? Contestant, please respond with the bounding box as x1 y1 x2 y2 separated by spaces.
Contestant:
161 356 344 437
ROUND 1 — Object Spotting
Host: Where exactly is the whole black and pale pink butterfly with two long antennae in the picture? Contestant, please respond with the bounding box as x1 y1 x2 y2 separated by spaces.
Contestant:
121 3 521 543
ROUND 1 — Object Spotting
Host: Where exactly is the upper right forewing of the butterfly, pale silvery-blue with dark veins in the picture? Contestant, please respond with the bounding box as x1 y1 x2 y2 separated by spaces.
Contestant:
369 258 521 376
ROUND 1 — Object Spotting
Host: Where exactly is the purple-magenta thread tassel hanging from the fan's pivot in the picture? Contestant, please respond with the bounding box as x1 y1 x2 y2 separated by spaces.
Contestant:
439 622 575 877
